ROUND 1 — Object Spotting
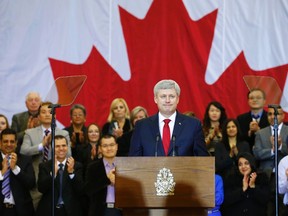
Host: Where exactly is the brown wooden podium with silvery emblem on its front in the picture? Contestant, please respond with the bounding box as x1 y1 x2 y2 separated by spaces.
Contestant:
115 157 215 216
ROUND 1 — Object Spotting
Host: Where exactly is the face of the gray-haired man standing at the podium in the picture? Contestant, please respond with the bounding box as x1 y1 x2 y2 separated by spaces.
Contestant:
154 89 179 117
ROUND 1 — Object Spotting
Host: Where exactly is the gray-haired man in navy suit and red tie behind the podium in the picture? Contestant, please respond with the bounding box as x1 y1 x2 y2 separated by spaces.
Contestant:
129 80 208 156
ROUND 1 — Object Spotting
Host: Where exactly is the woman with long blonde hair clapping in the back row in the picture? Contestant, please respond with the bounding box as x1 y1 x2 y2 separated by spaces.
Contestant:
102 98 131 139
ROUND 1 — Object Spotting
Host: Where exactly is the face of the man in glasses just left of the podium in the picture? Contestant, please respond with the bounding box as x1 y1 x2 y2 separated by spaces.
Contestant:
99 137 118 159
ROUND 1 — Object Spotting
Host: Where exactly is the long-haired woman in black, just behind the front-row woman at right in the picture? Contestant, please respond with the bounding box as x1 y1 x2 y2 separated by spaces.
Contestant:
215 119 250 178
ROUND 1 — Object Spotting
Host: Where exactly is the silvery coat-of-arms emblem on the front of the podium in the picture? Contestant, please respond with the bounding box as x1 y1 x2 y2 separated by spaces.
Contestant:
154 168 176 196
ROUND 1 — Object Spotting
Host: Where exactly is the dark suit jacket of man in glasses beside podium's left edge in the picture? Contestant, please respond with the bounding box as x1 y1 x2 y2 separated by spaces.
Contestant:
85 158 111 216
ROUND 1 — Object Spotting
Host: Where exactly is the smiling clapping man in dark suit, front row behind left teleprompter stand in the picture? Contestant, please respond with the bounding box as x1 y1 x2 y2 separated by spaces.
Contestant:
36 135 84 216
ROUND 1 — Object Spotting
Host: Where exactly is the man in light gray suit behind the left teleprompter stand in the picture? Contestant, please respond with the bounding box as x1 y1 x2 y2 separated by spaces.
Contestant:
20 102 71 209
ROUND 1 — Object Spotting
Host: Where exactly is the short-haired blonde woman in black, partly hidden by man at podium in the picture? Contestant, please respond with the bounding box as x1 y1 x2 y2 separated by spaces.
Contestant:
117 106 148 156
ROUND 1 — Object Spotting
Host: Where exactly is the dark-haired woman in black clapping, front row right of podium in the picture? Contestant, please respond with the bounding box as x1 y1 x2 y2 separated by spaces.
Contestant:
222 152 270 216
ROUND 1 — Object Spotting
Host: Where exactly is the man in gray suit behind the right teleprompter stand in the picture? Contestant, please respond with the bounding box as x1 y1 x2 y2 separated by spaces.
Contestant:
253 106 288 216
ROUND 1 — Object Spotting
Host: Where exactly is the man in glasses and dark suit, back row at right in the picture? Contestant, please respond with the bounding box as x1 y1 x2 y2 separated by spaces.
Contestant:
237 89 269 152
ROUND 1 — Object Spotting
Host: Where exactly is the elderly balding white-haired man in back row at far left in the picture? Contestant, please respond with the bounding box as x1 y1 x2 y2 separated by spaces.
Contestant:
11 92 41 145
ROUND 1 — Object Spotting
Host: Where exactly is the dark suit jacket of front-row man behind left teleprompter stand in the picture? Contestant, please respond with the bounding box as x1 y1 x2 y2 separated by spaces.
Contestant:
36 160 83 216
